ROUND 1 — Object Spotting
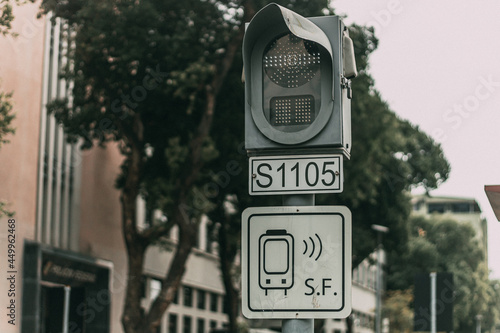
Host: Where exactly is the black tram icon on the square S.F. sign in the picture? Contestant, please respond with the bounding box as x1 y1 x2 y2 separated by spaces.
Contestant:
259 229 294 295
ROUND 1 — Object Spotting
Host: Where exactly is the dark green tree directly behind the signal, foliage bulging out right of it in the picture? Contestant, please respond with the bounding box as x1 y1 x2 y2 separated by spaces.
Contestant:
206 16 450 333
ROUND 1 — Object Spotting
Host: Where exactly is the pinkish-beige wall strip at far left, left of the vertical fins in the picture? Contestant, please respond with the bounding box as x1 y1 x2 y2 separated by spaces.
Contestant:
0 4 44 333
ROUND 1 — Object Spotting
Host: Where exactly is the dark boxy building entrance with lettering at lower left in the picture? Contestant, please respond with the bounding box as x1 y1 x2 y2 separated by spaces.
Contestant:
21 241 112 333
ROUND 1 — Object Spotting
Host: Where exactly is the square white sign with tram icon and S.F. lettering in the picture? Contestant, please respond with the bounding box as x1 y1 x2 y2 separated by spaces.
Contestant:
241 206 351 319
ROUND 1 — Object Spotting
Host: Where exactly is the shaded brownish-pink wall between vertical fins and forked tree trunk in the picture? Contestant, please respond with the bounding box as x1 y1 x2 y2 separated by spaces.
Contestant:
80 144 127 333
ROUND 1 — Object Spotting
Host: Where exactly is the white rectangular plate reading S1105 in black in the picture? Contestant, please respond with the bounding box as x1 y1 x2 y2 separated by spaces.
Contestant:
249 155 344 195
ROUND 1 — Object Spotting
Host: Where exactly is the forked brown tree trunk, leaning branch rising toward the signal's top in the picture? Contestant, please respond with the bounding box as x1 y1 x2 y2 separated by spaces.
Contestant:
122 0 255 333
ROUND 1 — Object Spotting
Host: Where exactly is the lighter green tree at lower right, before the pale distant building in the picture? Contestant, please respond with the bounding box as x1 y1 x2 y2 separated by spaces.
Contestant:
388 216 500 332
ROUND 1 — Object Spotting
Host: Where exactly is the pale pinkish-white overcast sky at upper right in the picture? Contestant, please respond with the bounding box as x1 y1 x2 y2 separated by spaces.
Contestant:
332 0 500 279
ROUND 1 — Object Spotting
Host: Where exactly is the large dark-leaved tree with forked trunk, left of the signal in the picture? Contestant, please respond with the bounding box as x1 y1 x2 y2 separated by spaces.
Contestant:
37 0 326 332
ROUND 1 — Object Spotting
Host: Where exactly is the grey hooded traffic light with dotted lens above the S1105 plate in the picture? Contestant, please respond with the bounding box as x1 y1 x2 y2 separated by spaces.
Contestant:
243 4 357 158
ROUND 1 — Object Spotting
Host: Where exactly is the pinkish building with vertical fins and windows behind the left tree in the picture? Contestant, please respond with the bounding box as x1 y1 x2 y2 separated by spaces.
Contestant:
0 3 227 333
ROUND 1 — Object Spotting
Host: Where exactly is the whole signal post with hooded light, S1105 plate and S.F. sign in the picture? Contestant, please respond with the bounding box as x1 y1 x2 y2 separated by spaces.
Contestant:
242 4 357 333
